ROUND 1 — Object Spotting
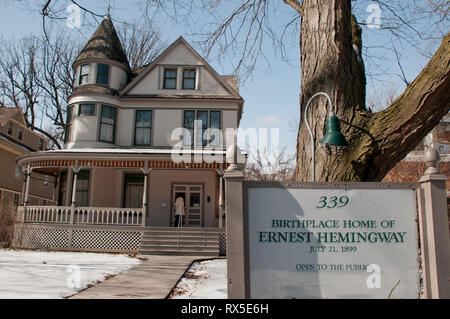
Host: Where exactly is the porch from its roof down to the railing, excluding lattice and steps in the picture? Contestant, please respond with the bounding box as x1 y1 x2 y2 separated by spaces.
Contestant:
18 150 229 228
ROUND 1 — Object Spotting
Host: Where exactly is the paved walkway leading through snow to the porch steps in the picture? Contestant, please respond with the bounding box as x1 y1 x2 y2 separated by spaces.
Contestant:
70 255 205 299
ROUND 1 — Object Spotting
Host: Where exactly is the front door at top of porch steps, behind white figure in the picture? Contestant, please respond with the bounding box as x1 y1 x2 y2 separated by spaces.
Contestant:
172 184 203 227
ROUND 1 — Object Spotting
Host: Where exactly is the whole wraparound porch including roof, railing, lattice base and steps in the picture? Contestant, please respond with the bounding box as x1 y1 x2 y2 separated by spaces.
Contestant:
14 149 226 256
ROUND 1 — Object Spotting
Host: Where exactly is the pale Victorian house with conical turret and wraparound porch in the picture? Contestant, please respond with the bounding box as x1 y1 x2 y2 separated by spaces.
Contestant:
17 16 244 258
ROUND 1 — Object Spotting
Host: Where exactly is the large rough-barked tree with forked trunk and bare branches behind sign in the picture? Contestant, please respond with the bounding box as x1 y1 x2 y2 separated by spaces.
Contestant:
15 0 450 181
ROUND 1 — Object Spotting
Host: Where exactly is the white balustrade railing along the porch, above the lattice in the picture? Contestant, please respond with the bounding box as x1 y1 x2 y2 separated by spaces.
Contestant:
19 206 145 226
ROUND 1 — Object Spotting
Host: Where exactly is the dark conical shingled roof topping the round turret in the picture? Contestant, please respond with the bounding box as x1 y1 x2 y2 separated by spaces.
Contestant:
74 18 130 69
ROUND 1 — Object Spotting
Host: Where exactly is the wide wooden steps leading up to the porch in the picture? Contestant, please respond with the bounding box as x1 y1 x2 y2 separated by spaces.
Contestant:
139 227 223 256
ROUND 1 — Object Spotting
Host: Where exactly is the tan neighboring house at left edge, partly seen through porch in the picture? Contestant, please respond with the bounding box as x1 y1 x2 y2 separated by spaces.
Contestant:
0 106 54 216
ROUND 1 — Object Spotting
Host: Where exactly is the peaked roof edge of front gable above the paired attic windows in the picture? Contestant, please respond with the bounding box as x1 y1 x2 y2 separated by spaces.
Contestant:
119 36 241 98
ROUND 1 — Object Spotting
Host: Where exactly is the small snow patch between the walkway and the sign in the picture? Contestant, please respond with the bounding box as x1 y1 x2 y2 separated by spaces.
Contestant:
171 259 227 299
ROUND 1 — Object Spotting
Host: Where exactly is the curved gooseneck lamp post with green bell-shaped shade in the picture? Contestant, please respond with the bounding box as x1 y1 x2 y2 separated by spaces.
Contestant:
305 92 348 182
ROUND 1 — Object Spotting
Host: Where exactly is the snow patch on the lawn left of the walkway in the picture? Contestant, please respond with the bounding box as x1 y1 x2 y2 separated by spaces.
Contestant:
0 249 141 299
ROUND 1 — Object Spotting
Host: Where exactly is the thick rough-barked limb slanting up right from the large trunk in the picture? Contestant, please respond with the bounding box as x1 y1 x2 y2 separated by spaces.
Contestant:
351 33 450 181
